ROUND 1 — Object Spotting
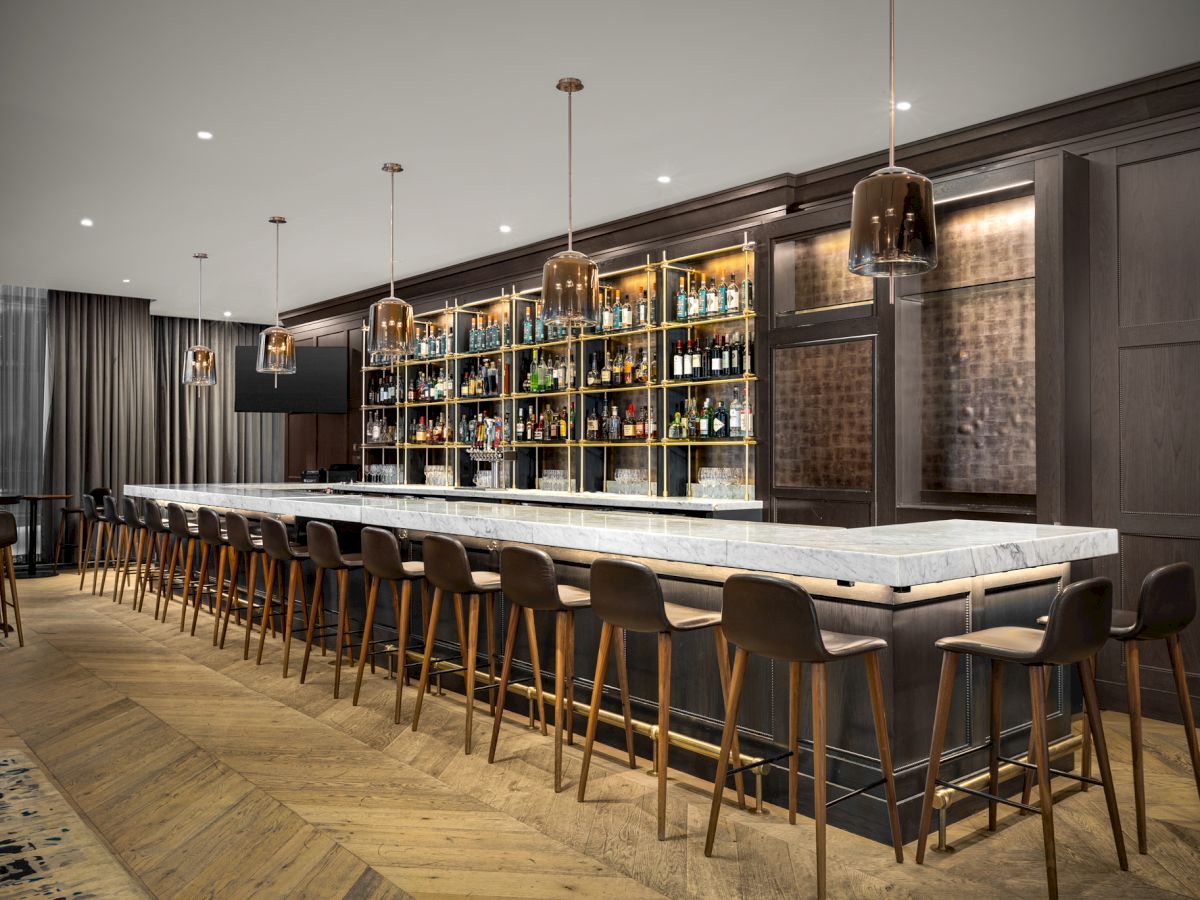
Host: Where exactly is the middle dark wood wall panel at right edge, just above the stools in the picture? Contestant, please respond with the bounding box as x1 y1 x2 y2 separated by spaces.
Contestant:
1118 343 1200 516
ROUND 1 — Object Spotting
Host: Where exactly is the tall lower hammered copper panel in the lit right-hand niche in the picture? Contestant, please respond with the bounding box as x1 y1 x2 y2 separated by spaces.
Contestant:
920 278 1037 494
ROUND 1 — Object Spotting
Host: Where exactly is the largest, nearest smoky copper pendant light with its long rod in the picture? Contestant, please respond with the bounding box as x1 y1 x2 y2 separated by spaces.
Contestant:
850 0 937 278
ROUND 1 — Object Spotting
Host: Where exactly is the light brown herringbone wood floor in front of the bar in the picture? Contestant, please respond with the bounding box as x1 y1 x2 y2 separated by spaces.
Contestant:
0 576 1200 899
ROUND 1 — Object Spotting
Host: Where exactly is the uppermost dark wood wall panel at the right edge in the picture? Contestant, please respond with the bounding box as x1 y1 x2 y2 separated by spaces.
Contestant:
1117 150 1200 326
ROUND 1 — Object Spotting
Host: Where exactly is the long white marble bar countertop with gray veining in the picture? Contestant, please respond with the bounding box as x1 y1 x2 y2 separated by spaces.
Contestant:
125 485 1117 587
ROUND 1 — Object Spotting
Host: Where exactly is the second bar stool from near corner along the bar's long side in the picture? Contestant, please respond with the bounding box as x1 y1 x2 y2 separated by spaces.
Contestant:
578 557 745 841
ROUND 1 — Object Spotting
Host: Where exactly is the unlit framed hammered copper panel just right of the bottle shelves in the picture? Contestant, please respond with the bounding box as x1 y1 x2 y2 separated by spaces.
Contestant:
772 340 875 490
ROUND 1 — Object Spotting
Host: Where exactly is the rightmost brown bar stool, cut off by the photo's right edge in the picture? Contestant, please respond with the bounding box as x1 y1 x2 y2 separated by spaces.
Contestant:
1109 563 1200 853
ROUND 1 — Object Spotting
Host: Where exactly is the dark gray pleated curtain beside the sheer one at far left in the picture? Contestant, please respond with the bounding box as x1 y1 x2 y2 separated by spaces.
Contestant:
43 290 157 498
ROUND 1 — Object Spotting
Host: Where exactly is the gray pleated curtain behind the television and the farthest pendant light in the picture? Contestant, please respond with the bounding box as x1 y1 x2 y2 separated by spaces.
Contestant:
152 316 286 484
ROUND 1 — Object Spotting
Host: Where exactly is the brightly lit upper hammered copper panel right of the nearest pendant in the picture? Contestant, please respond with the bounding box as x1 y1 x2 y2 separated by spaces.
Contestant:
920 196 1034 293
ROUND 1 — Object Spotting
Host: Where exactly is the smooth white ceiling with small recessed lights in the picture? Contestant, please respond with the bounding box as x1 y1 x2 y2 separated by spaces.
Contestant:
0 0 1200 322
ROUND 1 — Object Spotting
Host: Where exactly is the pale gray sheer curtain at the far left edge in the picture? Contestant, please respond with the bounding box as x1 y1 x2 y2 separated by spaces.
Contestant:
0 284 47 553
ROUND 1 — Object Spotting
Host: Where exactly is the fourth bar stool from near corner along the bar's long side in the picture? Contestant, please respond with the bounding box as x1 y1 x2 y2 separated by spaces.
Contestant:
413 534 500 754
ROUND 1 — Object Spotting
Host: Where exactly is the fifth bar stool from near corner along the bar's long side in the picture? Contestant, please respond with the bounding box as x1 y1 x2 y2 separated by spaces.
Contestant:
354 528 425 725
